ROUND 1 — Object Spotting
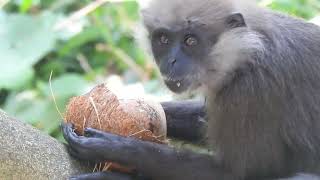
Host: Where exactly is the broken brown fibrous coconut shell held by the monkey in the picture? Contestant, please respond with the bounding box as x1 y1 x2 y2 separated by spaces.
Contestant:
65 84 167 172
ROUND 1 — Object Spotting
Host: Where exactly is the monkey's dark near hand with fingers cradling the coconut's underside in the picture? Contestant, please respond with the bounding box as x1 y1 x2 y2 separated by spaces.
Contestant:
62 124 154 165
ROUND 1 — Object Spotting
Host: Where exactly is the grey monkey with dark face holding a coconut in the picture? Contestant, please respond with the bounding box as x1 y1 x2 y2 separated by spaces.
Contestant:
62 0 320 180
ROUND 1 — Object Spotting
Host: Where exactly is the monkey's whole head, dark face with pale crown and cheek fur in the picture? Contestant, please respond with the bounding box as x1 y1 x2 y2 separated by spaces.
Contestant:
142 0 246 93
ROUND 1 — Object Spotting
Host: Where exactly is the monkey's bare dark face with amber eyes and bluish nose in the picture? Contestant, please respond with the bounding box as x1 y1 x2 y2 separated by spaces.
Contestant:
151 28 213 93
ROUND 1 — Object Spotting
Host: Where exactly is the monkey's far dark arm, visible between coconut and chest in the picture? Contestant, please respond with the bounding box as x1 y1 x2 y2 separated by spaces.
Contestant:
161 100 207 142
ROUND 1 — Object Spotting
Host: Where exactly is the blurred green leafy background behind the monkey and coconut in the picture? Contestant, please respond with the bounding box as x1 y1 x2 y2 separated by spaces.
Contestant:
0 0 320 140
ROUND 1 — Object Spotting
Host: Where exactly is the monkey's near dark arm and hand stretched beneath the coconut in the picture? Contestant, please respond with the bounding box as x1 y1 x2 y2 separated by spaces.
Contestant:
63 124 225 180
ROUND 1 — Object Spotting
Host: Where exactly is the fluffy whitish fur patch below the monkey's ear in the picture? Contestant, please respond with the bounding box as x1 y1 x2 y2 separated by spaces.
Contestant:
205 28 264 93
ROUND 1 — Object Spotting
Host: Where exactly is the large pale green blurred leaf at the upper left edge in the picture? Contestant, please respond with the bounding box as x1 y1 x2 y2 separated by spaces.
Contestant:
0 13 56 89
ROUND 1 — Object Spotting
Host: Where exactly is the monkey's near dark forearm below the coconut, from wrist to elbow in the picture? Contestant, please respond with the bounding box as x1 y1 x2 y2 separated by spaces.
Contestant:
111 136 216 180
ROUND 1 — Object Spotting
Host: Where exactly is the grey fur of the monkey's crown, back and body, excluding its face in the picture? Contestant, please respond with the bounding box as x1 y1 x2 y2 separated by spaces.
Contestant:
143 0 320 180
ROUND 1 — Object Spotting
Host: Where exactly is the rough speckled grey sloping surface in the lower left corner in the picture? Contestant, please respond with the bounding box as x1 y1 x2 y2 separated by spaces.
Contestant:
0 110 92 179
